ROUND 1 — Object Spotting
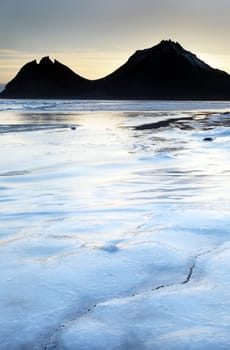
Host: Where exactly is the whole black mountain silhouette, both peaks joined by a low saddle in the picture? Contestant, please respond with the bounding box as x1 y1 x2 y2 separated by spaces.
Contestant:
0 40 230 99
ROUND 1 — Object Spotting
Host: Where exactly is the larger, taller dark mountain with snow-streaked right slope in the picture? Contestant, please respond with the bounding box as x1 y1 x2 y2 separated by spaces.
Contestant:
95 40 230 99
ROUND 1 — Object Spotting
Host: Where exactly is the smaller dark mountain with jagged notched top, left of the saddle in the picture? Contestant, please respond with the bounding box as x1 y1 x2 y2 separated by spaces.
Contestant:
0 57 91 98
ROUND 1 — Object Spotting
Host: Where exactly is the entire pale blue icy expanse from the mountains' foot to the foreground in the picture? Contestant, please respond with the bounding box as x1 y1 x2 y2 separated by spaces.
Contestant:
0 100 230 350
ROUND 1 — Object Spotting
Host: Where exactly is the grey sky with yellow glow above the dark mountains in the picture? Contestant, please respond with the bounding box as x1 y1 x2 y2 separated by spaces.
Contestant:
0 0 230 84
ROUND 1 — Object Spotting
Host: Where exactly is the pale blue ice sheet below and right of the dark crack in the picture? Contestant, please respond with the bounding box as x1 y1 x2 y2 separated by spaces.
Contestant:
56 244 230 350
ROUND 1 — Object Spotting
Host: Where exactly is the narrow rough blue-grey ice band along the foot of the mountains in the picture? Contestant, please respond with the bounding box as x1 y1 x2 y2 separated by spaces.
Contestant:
0 98 229 114
